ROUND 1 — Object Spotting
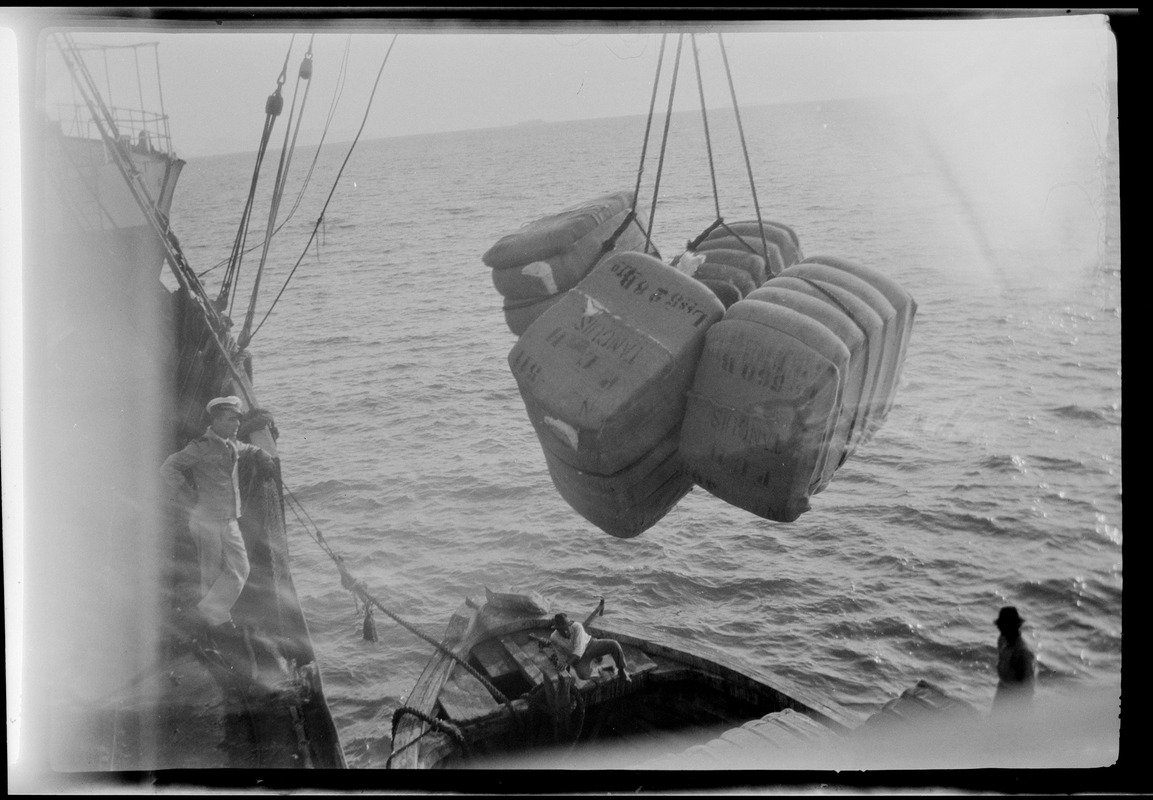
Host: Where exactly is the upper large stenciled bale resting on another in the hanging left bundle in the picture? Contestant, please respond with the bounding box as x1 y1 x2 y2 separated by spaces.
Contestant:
508 252 724 476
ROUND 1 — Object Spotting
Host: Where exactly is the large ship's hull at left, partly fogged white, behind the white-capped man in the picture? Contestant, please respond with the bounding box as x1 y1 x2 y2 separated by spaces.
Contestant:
24 126 345 776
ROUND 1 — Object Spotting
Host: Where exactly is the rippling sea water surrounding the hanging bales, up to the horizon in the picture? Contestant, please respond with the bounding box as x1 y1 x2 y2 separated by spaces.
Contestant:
172 84 1123 768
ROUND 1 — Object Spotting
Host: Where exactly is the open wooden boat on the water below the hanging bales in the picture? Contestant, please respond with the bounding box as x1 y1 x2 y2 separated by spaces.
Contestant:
390 594 861 769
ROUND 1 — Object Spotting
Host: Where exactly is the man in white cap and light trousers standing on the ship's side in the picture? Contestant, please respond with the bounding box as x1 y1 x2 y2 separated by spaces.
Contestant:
160 397 276 627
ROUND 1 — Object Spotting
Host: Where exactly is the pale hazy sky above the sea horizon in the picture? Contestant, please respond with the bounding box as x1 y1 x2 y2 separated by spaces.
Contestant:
0 9 1109 158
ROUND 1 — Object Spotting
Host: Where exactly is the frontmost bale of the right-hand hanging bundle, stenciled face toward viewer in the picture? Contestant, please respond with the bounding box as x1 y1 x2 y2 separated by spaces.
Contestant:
680 299 849 522
